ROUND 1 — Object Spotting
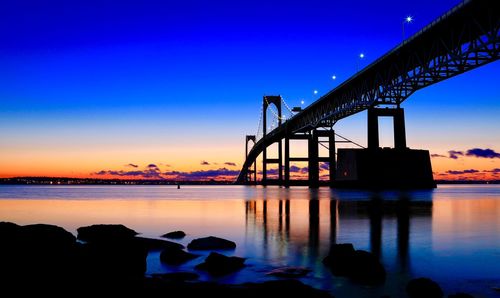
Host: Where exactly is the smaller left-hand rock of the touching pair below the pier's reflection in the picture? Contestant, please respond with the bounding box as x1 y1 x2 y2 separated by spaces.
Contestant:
323 243 354 276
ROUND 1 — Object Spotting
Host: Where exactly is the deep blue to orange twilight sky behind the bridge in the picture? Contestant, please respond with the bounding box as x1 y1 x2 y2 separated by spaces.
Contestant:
0 0 500 180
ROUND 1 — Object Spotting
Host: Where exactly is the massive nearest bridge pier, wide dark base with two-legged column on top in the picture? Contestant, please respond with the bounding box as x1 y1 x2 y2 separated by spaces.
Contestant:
335 107 436 189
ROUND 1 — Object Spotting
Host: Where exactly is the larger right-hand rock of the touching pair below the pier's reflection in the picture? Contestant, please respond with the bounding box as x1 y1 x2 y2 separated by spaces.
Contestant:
348 250 386 285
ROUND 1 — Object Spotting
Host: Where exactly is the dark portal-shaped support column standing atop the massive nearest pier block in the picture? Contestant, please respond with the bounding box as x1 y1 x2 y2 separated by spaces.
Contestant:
368 108 406 149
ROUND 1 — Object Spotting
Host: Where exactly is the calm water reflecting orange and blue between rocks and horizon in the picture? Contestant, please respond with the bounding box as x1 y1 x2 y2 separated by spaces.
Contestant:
0 185 500 297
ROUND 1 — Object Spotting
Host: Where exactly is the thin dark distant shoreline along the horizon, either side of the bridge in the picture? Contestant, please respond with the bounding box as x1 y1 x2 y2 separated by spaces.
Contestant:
0 177 500 185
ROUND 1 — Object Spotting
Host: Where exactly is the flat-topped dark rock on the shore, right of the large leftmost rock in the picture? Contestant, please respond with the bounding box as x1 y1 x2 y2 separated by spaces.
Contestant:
77 224 138 242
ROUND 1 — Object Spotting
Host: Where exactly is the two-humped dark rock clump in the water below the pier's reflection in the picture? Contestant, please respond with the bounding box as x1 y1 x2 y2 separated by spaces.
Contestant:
323 243 386 285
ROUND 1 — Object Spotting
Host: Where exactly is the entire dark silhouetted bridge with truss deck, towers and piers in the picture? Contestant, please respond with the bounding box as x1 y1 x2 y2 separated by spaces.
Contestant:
236 0 500 188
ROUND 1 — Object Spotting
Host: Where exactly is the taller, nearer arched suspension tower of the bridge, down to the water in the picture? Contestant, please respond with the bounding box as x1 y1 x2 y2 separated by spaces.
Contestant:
262 95 283 185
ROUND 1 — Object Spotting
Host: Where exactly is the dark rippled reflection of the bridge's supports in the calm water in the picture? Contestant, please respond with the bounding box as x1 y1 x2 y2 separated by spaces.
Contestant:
245 191 432 271
